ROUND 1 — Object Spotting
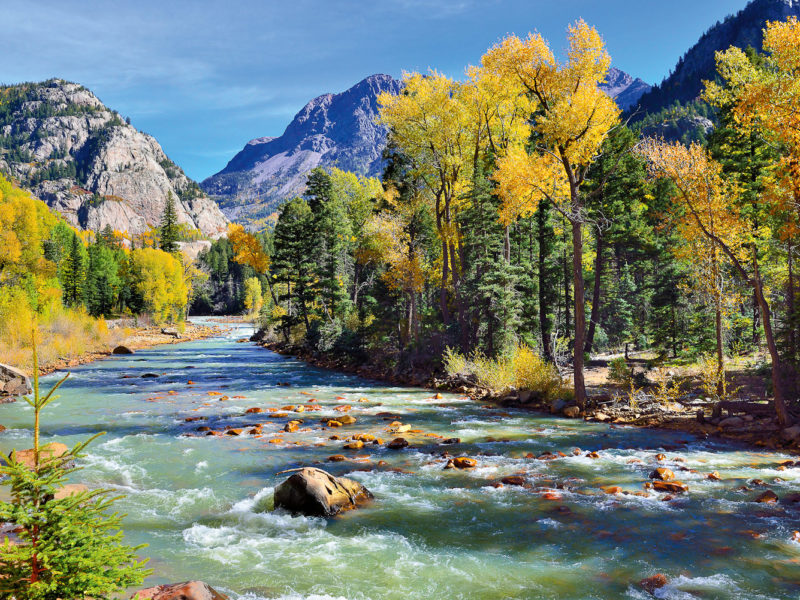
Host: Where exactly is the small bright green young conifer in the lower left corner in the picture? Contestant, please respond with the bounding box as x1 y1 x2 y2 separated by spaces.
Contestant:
0 332 151 600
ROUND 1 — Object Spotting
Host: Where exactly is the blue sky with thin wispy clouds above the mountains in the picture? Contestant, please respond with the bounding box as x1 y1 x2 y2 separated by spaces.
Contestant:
0 0 746 181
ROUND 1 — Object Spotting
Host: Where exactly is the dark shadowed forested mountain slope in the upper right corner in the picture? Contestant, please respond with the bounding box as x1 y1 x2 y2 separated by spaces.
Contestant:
639 0 800 113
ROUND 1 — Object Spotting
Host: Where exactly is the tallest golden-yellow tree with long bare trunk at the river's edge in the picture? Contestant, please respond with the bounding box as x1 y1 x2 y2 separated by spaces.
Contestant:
481 20 620 407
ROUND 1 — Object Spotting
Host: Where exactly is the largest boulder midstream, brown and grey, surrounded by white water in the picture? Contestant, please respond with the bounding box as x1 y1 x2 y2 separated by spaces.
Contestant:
274 467 373 517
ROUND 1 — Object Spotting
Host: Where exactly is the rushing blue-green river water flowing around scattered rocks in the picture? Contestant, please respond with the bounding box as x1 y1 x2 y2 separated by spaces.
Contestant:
0 326 800 600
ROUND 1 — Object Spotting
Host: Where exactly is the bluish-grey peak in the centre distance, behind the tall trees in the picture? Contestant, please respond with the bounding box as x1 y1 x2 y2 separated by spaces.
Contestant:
200 75 402 222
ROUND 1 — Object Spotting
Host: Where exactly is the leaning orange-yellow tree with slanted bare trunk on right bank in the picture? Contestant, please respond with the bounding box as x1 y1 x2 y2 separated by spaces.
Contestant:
641 140 790 425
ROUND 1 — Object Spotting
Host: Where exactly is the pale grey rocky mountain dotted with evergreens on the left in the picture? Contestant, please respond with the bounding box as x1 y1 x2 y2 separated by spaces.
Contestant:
0 79 228 237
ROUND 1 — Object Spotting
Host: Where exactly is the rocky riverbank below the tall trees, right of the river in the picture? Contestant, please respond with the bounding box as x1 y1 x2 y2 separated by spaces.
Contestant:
262 340 800 454
